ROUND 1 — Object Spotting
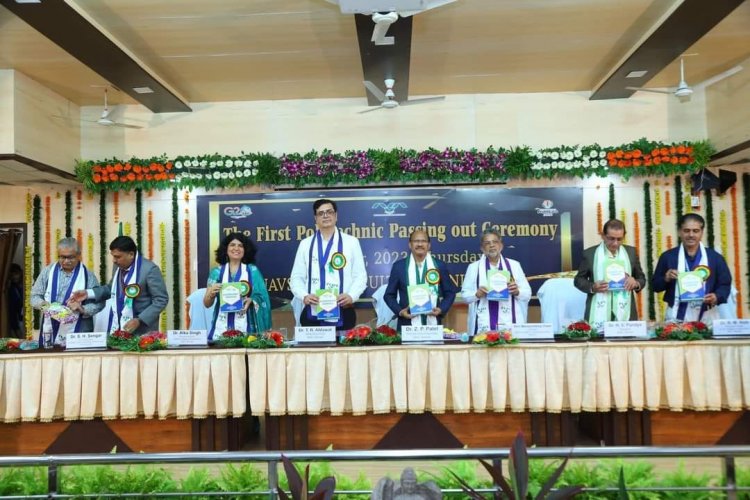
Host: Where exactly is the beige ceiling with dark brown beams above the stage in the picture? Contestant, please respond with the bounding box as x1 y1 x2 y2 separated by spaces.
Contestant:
0 0 750 183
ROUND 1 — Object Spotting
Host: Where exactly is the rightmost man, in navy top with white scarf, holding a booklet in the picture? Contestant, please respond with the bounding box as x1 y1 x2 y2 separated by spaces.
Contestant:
651 213 732 321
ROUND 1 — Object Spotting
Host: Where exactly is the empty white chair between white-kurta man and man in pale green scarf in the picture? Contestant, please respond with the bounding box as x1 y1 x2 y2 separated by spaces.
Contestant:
536 278 586 333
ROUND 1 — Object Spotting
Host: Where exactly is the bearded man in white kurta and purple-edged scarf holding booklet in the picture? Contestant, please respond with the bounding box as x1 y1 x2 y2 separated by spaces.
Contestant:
461 229 531 335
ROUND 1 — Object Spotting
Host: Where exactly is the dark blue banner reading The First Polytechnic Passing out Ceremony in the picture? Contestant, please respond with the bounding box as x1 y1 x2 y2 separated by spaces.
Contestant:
197 187 583 299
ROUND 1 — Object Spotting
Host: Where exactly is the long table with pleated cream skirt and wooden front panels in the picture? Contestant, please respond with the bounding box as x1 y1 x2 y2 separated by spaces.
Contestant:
0 340 750 453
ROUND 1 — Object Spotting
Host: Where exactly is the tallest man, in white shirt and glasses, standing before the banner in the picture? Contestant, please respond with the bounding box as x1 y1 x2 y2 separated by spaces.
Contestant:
290 199 367 330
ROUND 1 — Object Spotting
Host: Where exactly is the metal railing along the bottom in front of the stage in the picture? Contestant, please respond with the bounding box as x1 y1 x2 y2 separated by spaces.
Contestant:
0 446 750 500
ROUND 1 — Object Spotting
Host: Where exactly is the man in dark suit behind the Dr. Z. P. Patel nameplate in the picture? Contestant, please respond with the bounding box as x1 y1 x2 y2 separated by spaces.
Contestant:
383 229 457 327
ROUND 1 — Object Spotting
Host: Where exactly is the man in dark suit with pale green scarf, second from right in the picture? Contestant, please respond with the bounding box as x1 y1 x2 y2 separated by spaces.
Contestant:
575 219 646 327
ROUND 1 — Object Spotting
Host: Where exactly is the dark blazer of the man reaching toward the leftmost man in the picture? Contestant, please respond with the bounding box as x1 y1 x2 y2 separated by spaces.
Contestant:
92 259 169 335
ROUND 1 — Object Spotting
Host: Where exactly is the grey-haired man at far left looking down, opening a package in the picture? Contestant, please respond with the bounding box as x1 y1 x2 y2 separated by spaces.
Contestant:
31 238 103 345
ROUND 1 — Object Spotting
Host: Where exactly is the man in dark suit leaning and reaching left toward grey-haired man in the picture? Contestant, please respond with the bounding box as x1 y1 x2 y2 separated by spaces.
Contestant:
71 236 169 335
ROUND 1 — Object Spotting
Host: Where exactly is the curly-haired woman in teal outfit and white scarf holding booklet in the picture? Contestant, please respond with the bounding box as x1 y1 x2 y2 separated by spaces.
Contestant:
203 233 271 340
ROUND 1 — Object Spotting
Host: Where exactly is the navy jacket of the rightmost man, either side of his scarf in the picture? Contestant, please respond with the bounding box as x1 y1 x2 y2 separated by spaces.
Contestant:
651 246 732 307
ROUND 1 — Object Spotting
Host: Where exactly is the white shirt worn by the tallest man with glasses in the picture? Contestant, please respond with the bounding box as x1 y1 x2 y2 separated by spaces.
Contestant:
290 229 367 302
